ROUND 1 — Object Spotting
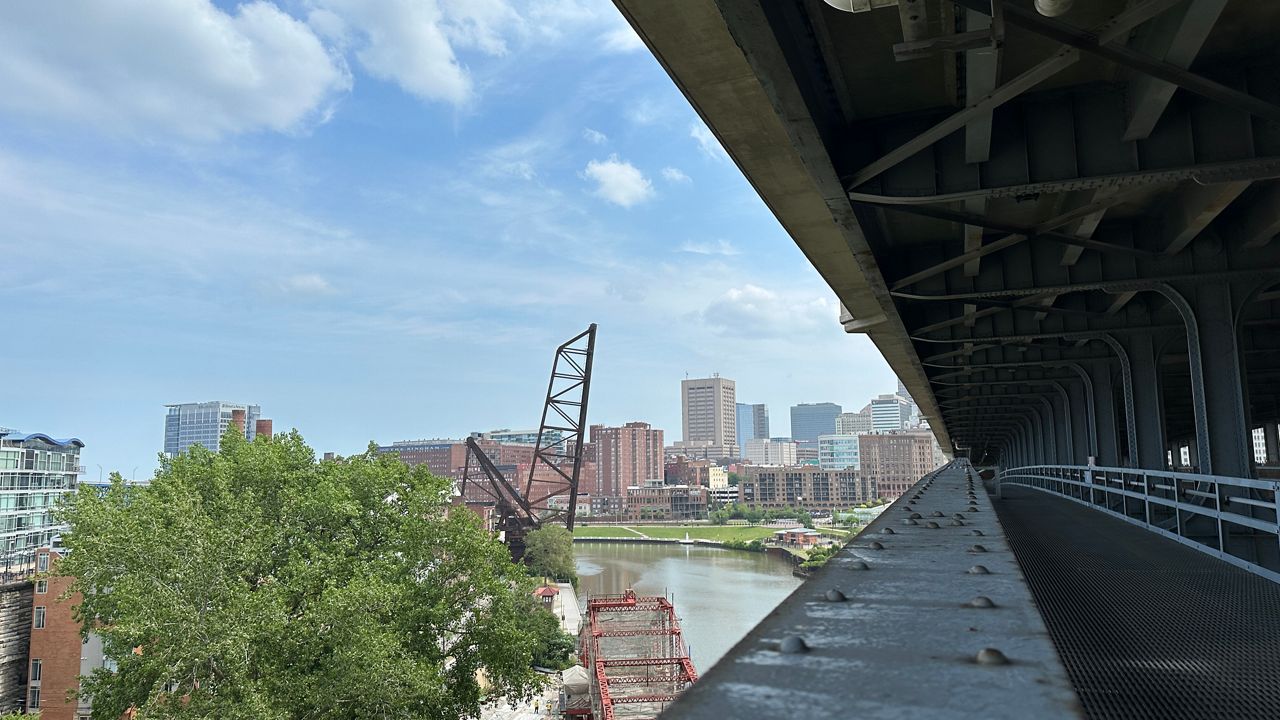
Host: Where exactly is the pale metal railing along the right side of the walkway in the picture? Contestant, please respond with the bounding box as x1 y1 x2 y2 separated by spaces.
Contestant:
996 465 1280 583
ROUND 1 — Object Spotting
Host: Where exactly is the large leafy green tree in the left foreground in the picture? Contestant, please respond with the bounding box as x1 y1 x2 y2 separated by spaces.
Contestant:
58 430 540 720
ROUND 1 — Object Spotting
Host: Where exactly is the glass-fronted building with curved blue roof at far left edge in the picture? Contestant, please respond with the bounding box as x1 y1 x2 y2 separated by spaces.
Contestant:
0 428 84 573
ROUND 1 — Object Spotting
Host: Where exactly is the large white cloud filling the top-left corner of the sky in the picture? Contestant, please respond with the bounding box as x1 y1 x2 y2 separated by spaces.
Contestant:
0 0 351 140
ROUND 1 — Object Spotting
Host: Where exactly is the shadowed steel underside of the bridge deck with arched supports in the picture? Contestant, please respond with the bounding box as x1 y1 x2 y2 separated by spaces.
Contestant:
616 0 1280 477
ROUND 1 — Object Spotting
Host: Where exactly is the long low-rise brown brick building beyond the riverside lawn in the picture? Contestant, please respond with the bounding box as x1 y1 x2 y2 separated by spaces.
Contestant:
737 465 876 510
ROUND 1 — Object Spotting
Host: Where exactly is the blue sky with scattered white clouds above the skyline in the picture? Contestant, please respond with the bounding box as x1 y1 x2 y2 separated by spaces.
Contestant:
0 0 895 477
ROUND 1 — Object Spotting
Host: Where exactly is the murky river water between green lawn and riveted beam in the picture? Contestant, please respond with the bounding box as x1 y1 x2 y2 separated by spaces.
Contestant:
573 542 800 674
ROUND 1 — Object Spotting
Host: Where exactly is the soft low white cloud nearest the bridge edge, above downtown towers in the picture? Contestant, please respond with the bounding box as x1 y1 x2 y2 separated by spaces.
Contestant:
701 284 840 337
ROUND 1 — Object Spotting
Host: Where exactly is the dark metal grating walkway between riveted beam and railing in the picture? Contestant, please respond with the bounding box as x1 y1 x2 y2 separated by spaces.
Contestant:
995 484 1280 720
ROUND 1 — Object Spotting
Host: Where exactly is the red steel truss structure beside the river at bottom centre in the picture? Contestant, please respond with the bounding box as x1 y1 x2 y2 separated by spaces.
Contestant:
567 589 698 720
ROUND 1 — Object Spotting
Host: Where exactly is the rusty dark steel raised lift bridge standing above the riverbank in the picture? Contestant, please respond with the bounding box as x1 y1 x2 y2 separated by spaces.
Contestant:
460 323 595 561
